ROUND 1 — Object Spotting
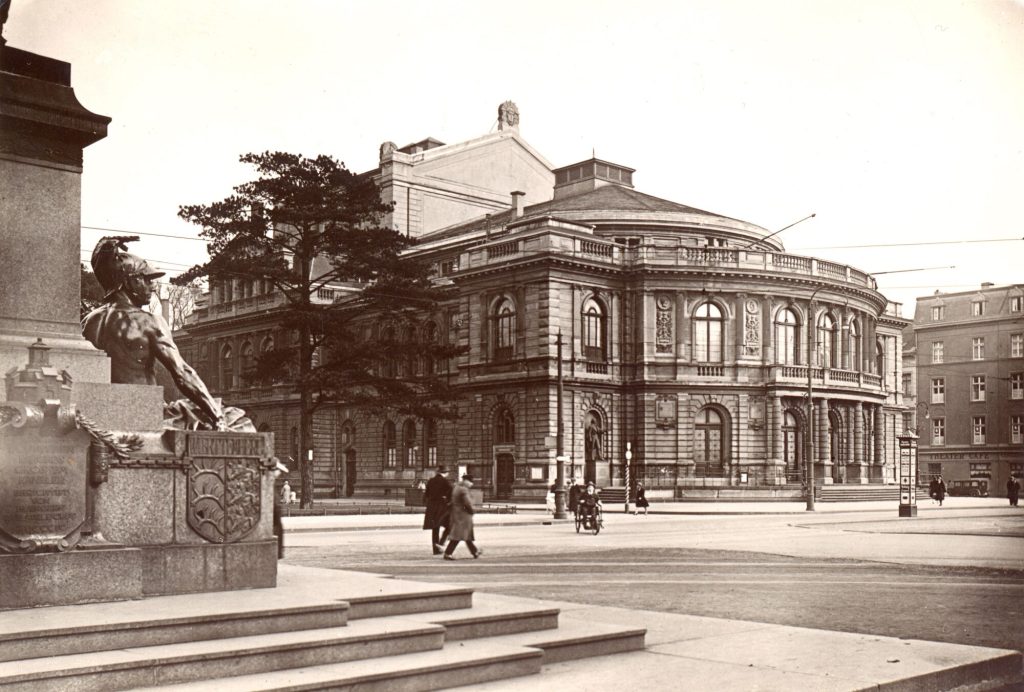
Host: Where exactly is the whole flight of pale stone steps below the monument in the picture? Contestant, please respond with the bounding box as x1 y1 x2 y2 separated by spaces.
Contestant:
0 564 645 692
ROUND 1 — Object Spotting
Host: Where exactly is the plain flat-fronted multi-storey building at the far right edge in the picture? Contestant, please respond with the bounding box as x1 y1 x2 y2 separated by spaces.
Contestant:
913 284 1024 494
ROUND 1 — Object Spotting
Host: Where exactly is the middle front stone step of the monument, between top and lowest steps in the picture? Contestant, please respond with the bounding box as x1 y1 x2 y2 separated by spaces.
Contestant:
0 618 444 692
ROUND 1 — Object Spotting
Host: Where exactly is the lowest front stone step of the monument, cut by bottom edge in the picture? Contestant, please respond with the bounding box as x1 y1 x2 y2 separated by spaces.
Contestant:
138 639 544 692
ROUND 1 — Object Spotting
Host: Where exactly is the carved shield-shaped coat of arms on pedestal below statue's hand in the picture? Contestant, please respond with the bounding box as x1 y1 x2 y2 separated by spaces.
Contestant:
186 458 261 543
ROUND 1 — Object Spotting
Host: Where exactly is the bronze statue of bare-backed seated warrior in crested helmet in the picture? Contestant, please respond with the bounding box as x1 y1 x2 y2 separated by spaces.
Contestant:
82 235 230 430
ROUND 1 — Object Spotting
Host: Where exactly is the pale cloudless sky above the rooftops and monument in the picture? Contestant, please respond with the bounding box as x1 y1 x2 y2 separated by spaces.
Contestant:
4 0 1024 317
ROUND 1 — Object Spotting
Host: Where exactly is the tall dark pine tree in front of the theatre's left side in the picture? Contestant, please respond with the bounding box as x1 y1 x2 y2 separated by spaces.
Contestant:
173 152 459 507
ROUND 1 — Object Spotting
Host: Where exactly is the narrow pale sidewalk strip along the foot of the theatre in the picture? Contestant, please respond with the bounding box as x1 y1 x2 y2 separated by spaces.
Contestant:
283 498 1024 532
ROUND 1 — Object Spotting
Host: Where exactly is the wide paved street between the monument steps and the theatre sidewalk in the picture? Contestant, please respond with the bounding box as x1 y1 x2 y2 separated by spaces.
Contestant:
287 506 1024 650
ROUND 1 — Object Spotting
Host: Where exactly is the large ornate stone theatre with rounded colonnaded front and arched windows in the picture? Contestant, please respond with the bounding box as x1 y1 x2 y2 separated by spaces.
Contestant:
179 103 907 498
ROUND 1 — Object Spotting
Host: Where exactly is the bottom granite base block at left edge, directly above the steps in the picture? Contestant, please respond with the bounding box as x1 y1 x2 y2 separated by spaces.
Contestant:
0 548 144 609
